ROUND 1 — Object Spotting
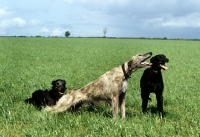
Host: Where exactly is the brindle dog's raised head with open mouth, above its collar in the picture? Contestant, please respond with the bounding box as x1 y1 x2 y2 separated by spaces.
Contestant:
128 52 152 71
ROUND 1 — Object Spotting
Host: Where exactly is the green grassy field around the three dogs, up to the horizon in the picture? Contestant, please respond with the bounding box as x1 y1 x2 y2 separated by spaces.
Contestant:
0 37 200 137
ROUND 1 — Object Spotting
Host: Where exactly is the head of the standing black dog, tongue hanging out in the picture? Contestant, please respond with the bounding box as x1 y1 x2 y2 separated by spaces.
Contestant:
150 54 169 70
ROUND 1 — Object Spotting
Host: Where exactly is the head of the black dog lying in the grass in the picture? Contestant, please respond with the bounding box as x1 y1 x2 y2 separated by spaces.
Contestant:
51 79 67 95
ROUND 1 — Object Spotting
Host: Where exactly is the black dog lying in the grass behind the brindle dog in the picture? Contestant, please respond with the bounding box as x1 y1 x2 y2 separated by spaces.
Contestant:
25 79 66 110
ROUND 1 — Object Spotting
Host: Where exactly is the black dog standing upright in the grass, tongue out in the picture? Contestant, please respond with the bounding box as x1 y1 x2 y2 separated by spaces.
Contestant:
140 54 169 117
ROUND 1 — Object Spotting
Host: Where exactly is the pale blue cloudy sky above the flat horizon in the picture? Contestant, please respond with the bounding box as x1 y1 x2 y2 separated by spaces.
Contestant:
0 0 200 39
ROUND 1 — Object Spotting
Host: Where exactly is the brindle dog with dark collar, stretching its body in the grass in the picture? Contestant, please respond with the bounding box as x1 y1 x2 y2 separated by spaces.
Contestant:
46 52 152 118
